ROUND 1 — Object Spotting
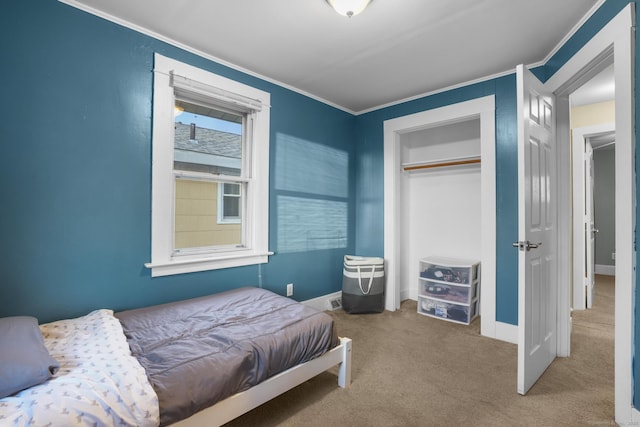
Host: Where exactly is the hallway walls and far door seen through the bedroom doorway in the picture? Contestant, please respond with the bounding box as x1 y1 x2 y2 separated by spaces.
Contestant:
570 59 615 310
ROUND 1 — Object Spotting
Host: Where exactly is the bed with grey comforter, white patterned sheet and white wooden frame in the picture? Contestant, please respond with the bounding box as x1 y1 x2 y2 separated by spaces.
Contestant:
0 288 351 426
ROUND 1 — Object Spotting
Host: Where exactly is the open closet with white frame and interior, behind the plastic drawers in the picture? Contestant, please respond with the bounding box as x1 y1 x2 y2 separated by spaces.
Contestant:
384 96 500 342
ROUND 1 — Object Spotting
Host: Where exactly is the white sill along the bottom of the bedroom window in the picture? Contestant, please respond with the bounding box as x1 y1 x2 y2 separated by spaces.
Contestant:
144 252 273 277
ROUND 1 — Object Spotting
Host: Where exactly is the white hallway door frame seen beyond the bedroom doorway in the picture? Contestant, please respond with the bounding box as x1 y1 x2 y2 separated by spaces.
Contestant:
571 123 616 310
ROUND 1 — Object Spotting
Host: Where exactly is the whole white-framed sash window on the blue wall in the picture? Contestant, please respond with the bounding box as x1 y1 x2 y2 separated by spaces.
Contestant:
146 54 270 277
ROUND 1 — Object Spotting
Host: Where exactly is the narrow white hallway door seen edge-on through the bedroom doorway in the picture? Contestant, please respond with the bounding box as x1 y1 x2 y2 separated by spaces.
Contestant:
584 140 598 308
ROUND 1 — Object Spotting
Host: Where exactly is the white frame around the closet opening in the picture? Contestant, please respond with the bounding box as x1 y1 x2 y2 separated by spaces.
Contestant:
384 95 502 342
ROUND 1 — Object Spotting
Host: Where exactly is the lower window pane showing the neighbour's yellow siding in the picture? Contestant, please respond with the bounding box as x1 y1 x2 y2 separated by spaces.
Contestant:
174 179 243 249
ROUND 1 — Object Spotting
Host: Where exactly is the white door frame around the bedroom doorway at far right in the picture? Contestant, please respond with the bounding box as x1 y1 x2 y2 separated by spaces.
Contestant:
546 3 640 424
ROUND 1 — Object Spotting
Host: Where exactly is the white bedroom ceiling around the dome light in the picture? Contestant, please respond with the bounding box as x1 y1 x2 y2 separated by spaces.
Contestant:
61 0 603 113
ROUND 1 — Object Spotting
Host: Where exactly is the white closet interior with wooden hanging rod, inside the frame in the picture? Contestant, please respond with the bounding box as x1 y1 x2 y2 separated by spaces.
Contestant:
398 118 482 300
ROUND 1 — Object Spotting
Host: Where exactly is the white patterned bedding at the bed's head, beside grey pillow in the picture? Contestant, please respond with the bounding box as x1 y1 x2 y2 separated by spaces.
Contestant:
0 310 159 426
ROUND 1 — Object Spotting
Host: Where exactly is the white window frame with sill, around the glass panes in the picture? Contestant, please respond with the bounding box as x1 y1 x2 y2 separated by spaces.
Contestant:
145 53 271 277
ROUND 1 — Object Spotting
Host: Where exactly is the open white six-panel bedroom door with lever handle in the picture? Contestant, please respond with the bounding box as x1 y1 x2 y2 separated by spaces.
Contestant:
514 65 557 394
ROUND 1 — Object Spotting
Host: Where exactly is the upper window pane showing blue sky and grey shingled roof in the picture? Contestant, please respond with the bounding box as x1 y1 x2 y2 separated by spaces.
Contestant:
173 99 243 176
